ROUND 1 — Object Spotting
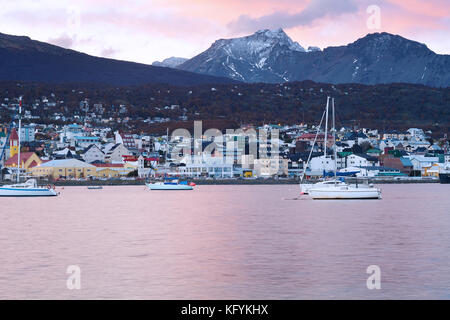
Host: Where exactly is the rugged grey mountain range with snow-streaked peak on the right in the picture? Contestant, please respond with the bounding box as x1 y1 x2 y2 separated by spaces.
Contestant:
179 29 450 87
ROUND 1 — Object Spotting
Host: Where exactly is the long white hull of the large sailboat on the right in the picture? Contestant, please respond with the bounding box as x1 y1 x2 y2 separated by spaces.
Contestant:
309 188 381 200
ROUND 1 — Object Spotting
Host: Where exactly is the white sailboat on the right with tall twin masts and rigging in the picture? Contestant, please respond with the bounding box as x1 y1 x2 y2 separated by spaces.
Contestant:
301 97 381 199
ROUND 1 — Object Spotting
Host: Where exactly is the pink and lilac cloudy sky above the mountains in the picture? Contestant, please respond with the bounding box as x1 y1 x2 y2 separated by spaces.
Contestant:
0 0 450 64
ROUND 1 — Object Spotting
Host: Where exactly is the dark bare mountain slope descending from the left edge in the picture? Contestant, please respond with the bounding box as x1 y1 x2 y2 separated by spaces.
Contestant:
0 33 234 85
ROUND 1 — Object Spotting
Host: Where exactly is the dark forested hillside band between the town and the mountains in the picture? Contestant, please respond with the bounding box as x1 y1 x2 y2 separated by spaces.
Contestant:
0 81 450 133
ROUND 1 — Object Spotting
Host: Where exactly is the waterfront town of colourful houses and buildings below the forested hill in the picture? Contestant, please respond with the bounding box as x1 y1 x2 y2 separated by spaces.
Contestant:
0 97 450 181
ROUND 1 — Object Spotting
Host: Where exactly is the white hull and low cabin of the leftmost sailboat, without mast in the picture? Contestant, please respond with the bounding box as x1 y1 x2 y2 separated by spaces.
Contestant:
0 179 58 197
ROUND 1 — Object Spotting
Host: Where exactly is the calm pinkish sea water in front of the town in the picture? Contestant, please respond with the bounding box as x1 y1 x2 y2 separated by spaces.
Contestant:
0 184 450 299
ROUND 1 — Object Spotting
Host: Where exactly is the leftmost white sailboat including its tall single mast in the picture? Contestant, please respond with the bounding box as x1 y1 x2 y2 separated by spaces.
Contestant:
0 97 58 197
